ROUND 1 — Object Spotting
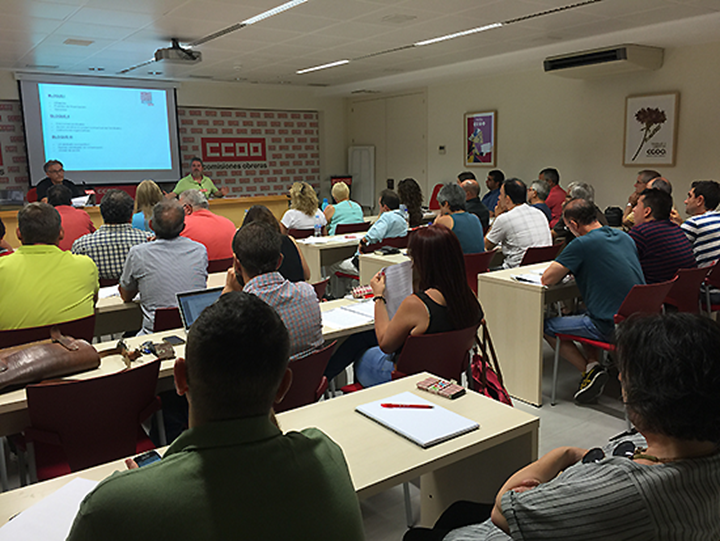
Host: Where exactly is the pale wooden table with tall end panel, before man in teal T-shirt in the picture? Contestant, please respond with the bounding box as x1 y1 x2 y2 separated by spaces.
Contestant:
478 263 580 406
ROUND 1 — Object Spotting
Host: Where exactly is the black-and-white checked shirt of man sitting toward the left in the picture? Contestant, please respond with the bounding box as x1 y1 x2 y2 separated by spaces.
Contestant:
72 224 147 280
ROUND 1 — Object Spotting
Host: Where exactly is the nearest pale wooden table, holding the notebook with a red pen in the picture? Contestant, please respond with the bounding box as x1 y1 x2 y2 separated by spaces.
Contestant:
0 373 539 526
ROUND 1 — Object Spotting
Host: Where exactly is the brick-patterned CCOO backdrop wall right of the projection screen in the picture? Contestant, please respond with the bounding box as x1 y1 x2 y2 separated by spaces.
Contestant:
178 107 320 197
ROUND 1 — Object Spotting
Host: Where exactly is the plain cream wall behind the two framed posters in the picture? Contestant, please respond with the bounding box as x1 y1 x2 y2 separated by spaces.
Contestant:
427 43 720 215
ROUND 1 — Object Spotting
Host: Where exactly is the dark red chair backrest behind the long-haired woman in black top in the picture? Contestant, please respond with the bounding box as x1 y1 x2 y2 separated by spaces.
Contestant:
393 325 478 382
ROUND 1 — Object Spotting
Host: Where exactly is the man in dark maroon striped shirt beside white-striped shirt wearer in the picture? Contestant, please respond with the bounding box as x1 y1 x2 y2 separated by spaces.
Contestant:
629 188 697 284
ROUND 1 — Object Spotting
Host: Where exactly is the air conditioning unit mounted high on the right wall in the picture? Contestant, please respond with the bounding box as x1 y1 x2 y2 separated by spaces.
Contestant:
543 45 663 79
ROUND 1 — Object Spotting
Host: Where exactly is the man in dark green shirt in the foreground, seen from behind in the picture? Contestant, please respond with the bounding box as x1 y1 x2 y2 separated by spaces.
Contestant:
68 292 363 541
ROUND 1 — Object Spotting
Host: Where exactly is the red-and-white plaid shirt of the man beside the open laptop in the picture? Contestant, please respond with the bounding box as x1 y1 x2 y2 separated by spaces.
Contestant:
243 272 323 360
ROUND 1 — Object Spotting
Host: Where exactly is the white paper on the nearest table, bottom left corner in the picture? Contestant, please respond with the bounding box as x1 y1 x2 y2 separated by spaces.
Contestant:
0 477 98 541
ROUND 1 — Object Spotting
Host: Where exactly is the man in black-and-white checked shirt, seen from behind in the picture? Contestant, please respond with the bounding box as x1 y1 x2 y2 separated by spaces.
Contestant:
72 190 147 280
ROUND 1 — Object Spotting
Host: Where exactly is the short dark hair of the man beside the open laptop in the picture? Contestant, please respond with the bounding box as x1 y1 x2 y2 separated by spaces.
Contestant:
233 222 282 277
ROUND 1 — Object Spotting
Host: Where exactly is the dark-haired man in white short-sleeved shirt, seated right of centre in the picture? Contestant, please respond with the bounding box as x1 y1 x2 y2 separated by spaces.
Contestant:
485 178 552 269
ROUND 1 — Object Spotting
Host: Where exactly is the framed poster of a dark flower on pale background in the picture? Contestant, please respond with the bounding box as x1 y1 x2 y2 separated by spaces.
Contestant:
623 92 680 166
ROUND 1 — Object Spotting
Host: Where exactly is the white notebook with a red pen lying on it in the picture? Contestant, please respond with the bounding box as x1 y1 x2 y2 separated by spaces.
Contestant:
355 391 480 448
